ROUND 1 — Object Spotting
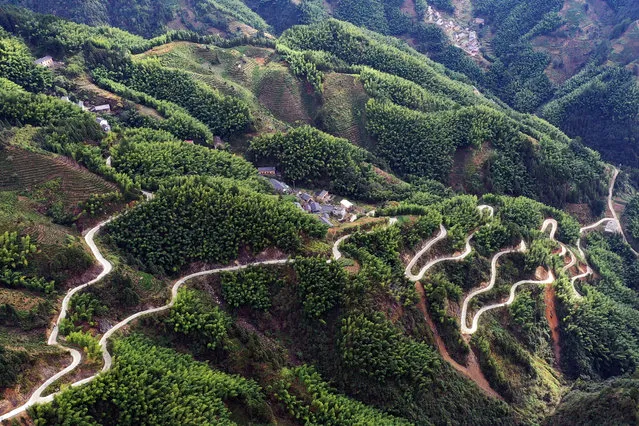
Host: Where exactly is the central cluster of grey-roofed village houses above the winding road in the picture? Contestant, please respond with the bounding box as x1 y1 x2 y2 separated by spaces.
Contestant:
257 167 357 226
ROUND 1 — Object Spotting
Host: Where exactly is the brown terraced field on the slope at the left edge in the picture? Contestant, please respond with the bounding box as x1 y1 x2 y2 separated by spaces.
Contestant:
0 146 117 203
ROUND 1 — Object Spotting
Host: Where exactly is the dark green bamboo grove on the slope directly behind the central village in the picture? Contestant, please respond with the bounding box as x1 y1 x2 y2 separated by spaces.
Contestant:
247 126 410 200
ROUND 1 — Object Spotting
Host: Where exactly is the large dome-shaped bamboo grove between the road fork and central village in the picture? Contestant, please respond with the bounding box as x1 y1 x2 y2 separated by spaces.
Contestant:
107 178 326 271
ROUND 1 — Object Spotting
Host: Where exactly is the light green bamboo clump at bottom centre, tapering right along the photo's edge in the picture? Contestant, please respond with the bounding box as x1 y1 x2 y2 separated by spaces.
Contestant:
275 365 412 426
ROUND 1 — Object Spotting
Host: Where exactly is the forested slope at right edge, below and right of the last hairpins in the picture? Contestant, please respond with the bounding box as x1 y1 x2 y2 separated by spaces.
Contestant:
557 230 639 378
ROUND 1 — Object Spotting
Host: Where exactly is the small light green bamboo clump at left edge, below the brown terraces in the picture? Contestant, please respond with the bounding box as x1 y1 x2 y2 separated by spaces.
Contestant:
0 231 54 293
